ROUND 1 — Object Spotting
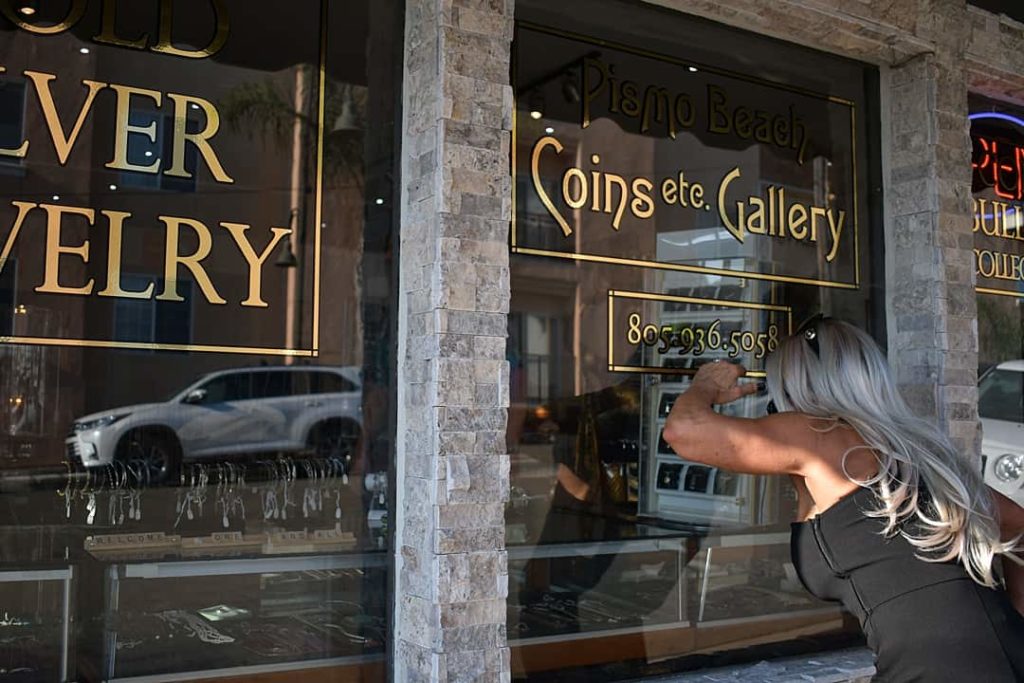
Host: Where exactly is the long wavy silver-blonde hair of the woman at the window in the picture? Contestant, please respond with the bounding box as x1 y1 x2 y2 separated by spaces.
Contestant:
767 318 1013 587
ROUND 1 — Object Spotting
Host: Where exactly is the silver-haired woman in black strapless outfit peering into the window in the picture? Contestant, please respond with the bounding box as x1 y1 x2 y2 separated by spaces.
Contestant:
664 316 1024 683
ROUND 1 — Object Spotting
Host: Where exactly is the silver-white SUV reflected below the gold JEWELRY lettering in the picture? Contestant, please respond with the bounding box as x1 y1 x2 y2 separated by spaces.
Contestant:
66 366 361 479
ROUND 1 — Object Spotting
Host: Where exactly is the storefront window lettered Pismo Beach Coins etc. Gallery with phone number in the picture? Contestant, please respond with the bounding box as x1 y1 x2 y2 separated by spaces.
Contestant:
507 1 885 681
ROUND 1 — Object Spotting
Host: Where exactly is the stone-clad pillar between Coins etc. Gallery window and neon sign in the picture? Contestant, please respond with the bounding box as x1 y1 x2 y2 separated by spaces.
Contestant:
884 2 978 454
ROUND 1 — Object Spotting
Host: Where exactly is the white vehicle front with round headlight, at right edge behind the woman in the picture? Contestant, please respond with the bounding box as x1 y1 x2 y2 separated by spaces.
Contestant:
978 360 1024 506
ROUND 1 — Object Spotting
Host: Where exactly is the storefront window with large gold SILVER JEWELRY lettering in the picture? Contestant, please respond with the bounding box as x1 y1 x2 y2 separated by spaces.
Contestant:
0 0 402 681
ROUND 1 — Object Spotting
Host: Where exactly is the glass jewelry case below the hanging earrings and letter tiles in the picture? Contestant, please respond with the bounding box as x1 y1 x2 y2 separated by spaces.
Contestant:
82 552 386 682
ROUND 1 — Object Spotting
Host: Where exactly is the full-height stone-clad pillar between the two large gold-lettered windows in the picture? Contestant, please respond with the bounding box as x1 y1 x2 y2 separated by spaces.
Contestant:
393 0 513 682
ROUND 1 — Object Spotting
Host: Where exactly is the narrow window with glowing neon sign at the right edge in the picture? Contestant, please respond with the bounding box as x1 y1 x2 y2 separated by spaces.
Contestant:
970 97 1024 524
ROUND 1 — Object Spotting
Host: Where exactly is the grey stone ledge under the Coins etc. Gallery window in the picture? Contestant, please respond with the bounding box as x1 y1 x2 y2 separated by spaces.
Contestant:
626 648 874 683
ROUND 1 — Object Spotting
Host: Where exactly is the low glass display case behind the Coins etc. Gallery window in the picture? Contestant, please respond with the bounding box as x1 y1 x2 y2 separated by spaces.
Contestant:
508 524 847 672
